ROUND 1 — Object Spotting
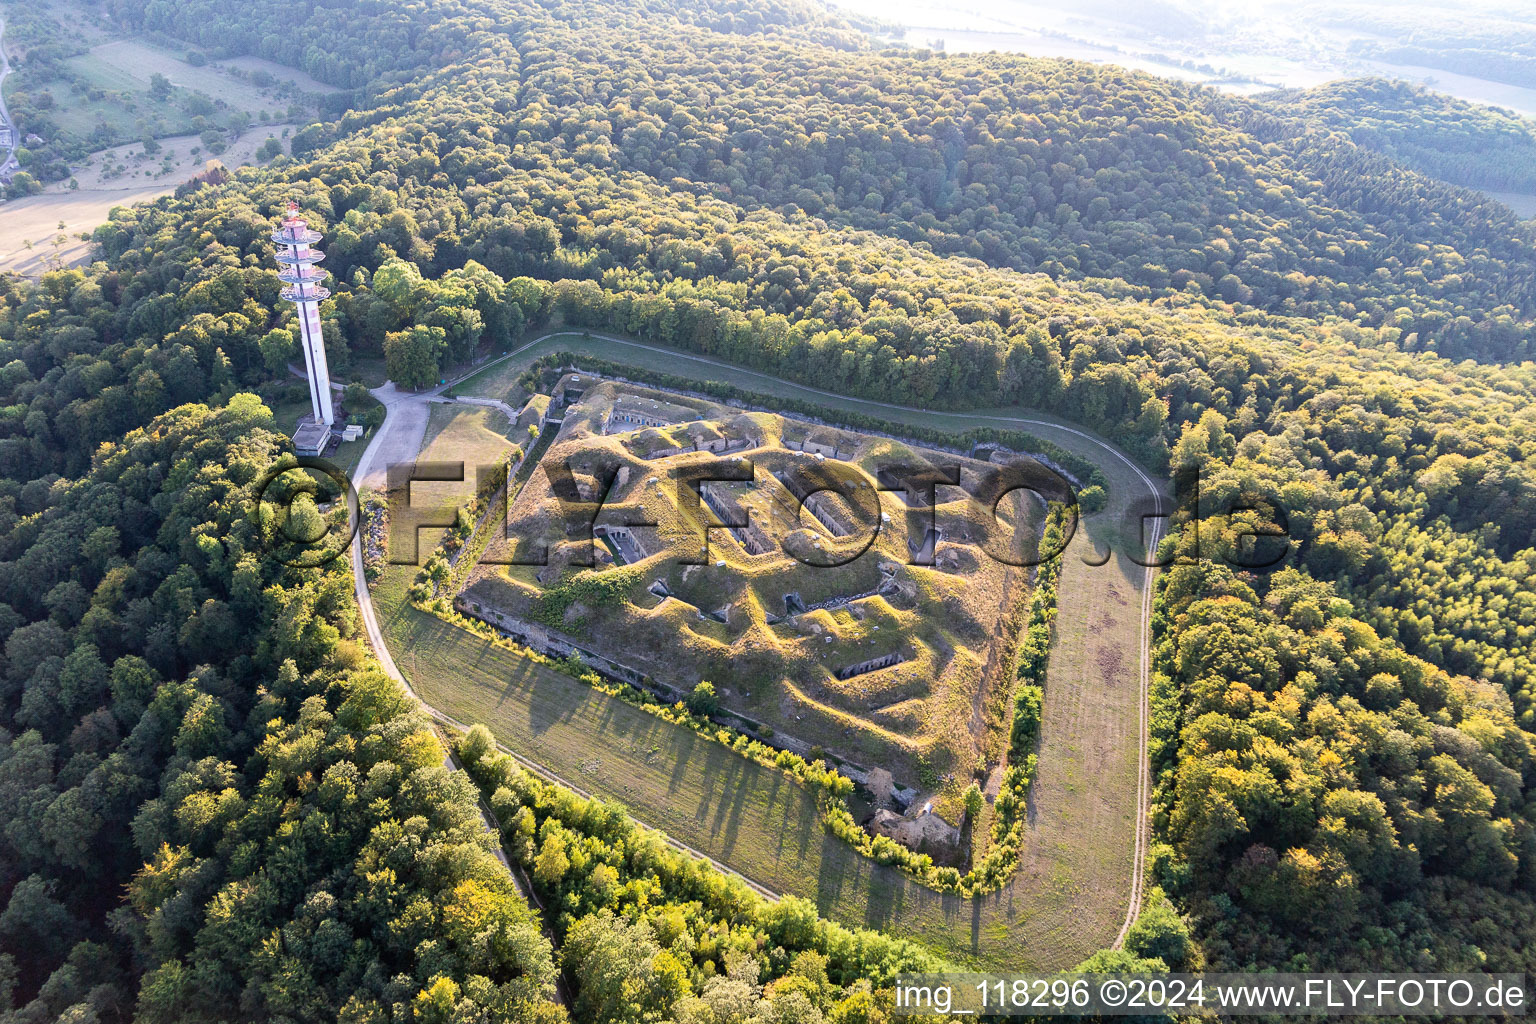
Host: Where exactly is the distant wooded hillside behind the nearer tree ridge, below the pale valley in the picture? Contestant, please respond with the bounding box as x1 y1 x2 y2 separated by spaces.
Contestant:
102 0 1536 359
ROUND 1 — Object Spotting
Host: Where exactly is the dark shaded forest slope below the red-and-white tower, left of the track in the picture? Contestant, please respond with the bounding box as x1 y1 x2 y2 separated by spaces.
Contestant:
0 393 562 1021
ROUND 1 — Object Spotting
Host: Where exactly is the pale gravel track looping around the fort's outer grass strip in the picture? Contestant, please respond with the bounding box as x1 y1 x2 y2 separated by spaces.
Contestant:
342 332 1164 947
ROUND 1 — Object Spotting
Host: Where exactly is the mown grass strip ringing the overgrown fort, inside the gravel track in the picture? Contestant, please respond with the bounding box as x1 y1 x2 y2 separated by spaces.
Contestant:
376 343 1144 969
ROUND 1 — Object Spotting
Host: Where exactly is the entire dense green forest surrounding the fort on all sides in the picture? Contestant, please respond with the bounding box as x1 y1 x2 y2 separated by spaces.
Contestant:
0 0 1536 1021
